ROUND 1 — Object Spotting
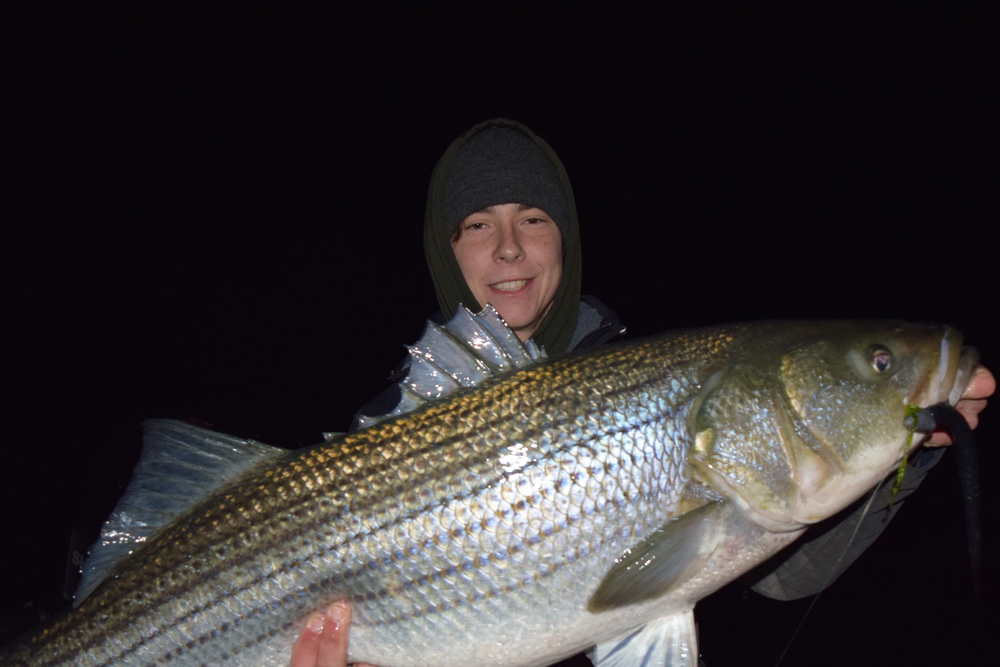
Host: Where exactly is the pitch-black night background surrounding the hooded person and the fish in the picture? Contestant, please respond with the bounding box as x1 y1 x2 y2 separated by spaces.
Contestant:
0 10 1000 667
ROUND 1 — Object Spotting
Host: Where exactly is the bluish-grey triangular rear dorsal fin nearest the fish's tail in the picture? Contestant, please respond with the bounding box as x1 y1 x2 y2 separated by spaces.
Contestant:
73 419 284 607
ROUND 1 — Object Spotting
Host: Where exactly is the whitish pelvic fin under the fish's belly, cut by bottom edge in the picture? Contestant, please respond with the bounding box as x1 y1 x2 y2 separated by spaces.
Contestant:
587 609 698 667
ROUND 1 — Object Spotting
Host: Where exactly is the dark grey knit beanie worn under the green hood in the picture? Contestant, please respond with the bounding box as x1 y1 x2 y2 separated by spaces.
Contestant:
443 127 569 238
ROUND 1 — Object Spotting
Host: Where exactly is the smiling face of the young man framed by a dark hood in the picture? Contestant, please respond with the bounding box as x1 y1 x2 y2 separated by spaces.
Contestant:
451 204 562 341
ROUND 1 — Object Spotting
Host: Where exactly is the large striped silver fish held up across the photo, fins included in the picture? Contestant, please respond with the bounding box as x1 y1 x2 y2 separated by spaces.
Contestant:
0 309 976 667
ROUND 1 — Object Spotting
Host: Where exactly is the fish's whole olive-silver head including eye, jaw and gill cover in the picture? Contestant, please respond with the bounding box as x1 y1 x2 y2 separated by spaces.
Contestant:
689 321 978 532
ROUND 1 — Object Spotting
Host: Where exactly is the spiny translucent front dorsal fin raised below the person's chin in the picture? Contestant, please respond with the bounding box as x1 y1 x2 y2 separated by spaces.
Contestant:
358 304 546 428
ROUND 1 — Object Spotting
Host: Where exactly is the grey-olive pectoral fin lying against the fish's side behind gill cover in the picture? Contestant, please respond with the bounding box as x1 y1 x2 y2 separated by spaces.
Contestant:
587 502 738 613
